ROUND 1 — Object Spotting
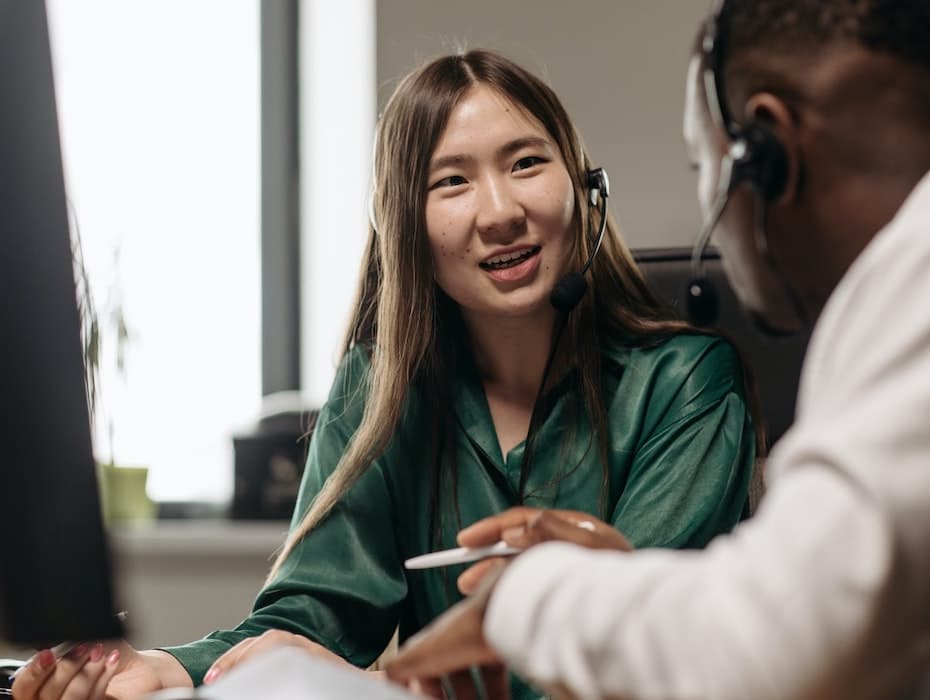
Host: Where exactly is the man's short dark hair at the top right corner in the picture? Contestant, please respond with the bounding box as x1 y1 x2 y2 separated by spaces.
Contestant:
718 0 930 70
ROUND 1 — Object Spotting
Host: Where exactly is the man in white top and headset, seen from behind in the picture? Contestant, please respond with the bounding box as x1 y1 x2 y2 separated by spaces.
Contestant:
388 0 930 700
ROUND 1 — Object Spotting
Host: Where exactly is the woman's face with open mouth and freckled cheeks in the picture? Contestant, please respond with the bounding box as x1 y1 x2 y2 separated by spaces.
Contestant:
426 86 575 318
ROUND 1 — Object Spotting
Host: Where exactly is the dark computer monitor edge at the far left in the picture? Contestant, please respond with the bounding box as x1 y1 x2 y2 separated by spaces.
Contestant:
0 0 122 647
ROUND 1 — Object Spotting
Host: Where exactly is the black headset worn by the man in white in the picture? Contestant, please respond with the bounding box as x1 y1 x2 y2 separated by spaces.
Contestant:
685 0 788 326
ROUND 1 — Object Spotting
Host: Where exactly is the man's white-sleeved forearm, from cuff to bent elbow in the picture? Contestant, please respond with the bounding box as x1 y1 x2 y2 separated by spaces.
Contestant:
485 470 891 700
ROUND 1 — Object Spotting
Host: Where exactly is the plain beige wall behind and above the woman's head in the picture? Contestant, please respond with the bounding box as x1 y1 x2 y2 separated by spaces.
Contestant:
377 0 709 247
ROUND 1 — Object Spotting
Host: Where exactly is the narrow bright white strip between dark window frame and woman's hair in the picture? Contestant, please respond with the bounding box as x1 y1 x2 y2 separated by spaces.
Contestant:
299 0 376 405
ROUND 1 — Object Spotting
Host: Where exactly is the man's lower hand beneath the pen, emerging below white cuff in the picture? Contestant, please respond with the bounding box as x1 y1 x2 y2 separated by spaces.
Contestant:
386 562 510 700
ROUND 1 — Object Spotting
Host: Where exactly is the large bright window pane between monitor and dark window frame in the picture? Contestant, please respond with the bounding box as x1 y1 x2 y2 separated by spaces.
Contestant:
48 0 261 500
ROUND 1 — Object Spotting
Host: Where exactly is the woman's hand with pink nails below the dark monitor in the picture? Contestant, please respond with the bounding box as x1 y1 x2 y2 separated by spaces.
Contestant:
13 641 191 700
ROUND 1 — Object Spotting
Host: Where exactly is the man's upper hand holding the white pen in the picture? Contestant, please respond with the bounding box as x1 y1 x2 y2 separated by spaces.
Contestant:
458 506 633 595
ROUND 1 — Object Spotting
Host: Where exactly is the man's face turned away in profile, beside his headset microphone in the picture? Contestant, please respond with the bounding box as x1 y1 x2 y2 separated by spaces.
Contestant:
684 56 799 331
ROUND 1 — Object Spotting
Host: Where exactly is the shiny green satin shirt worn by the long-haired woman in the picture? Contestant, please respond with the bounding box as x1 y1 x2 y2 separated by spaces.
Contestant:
168 335 755 699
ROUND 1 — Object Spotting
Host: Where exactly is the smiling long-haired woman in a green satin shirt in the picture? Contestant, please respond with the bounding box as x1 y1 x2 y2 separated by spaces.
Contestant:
17 51 755 698
